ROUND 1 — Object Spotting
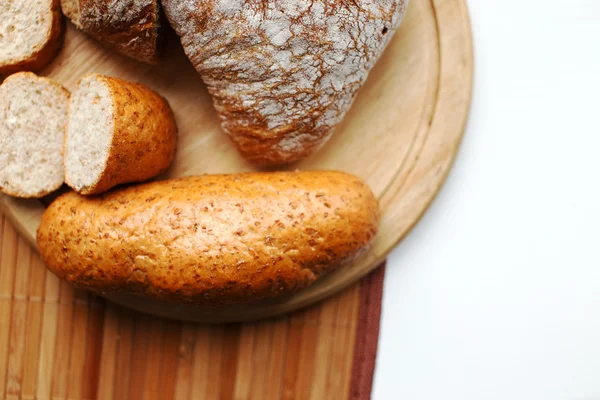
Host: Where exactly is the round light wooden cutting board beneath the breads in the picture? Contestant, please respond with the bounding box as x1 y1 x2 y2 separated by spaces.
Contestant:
0 0 473 322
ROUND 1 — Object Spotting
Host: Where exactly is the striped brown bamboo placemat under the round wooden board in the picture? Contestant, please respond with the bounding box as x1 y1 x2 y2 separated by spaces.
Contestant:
0 217 383 400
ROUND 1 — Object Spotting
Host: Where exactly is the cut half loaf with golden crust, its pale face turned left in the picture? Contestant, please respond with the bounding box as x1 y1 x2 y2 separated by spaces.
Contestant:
65 74 177 194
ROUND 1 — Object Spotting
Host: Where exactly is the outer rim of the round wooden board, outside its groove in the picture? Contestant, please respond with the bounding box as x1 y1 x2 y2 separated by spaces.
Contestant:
0 0 473 323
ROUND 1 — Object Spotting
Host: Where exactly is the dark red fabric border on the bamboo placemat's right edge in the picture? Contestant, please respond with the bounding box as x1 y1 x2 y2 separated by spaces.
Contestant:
349 263 385 400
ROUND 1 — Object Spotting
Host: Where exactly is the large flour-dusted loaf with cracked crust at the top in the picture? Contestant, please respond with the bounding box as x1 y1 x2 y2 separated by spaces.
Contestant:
162 0 407 165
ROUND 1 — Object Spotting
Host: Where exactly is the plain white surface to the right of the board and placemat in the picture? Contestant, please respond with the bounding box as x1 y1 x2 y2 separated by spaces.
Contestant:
373 0 600 400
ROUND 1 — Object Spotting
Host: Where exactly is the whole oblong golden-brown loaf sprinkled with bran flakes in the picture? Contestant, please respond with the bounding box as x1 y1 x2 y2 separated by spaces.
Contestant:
37 171 378 304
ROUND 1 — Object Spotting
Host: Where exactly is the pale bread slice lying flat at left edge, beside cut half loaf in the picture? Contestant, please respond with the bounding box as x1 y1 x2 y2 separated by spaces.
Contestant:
0 72 69 198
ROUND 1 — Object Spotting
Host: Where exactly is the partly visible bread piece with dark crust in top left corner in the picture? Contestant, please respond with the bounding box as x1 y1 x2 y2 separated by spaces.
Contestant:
0 0 63 76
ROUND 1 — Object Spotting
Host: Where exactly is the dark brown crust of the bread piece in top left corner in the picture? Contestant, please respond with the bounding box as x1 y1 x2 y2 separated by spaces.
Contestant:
0 0 64 76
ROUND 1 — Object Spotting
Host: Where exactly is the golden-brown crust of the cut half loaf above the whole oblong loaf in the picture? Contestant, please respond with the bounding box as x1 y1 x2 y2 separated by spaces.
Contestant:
65 74 177 195
